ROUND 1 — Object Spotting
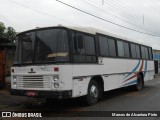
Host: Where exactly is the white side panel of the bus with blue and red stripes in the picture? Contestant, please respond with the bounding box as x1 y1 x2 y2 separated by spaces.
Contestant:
73 58 154 94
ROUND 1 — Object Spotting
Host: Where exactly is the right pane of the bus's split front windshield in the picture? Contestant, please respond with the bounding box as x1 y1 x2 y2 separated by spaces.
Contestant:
36 29 68 62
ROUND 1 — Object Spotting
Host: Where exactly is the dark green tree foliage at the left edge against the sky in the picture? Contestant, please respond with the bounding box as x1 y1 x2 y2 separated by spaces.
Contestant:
0 22 16 41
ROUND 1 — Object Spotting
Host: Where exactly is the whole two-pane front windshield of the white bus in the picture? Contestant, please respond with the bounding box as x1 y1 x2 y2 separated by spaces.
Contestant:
14 28 69 64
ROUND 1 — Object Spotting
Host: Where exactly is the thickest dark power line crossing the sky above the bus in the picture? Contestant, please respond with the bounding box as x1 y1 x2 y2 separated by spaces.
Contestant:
56 0 160 37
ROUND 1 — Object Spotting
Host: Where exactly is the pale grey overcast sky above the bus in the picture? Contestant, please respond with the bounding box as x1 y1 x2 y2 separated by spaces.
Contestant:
0 0 160 50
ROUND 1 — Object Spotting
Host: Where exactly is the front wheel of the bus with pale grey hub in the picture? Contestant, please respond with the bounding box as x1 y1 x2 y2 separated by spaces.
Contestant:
86 80 99 106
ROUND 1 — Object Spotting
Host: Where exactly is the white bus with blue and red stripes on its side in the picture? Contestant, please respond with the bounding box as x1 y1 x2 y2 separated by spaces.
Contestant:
11 26 154 105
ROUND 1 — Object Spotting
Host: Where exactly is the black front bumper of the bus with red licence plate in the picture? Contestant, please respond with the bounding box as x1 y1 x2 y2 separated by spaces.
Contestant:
10 89 72 99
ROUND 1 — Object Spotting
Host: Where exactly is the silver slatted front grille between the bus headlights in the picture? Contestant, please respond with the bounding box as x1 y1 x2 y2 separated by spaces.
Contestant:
17 75 50 89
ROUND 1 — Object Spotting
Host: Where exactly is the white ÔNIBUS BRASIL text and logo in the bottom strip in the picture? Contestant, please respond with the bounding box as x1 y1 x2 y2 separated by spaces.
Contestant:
2 112 42 117
